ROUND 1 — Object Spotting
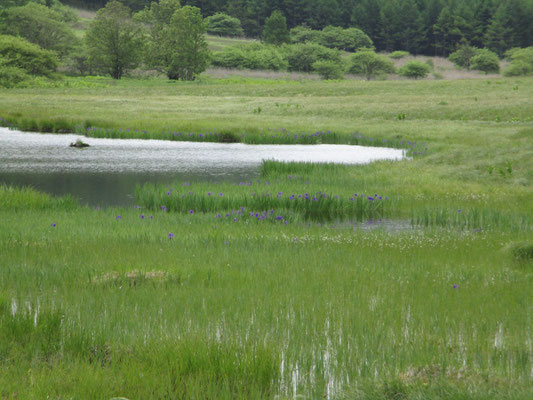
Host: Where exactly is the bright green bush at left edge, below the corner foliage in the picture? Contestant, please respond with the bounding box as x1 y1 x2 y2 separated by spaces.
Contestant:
0 35 59 79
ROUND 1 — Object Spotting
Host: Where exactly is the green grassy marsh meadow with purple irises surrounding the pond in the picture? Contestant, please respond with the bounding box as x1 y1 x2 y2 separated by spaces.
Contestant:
0 77 533 399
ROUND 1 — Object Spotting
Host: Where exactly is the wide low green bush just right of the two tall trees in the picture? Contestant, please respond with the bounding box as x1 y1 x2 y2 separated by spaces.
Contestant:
211 43 288 71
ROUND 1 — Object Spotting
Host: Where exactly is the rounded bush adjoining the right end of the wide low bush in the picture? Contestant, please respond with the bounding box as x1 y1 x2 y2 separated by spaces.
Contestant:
286 43 341 72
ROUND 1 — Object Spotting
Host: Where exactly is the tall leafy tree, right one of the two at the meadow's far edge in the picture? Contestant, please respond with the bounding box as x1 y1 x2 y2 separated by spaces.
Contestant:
168 6 209 81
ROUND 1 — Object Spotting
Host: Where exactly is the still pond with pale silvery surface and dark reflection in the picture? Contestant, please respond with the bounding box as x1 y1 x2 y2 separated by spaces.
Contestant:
0 128 405 206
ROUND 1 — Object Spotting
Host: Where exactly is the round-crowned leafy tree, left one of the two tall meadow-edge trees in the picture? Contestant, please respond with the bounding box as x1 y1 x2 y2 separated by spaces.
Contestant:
85 0 144 79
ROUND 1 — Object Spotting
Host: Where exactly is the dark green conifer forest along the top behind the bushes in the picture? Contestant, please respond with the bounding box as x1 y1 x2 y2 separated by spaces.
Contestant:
53 0 533 56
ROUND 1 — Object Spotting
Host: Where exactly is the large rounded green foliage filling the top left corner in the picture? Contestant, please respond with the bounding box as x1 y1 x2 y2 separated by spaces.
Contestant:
0 2 77 57
